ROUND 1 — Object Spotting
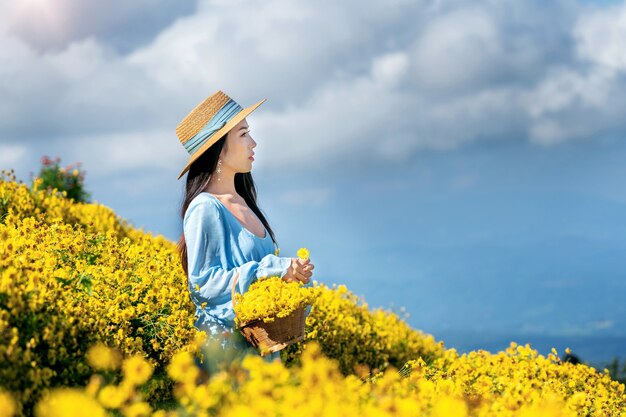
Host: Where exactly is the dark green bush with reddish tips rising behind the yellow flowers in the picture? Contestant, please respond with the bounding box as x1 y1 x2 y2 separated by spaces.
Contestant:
33 155 90 203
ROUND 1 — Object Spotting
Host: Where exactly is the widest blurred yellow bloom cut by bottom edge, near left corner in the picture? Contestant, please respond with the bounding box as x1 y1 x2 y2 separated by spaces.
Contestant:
35 388 107 417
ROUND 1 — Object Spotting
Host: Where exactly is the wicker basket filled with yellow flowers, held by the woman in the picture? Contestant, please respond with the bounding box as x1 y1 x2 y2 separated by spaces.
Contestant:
232 249 317 356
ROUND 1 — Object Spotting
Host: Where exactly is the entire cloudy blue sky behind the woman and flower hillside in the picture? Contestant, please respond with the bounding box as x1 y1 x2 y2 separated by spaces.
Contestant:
0 0 626 360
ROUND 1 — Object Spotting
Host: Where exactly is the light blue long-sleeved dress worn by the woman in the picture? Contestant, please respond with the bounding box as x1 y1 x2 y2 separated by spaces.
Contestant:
183 192 298 362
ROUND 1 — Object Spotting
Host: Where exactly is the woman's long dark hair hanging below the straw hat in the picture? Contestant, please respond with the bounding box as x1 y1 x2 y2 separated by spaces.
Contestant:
177 135 276 278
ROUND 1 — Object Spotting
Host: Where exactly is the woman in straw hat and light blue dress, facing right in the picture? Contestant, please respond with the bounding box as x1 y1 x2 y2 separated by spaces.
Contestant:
176 91 315 361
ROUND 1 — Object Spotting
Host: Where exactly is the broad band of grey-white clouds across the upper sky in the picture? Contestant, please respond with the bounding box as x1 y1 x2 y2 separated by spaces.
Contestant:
0 0 626 180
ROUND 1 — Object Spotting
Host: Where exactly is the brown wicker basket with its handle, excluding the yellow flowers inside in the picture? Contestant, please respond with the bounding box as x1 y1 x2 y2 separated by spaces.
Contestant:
231 274 307 356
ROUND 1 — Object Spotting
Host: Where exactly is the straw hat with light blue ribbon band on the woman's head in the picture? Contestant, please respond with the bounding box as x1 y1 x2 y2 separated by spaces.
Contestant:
176 90 266 179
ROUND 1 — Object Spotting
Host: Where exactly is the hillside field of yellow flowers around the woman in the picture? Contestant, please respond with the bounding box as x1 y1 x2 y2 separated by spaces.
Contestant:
0 172 626 417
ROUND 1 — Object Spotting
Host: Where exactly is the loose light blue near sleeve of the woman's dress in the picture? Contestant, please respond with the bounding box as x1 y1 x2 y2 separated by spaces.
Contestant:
183 195 291 305
